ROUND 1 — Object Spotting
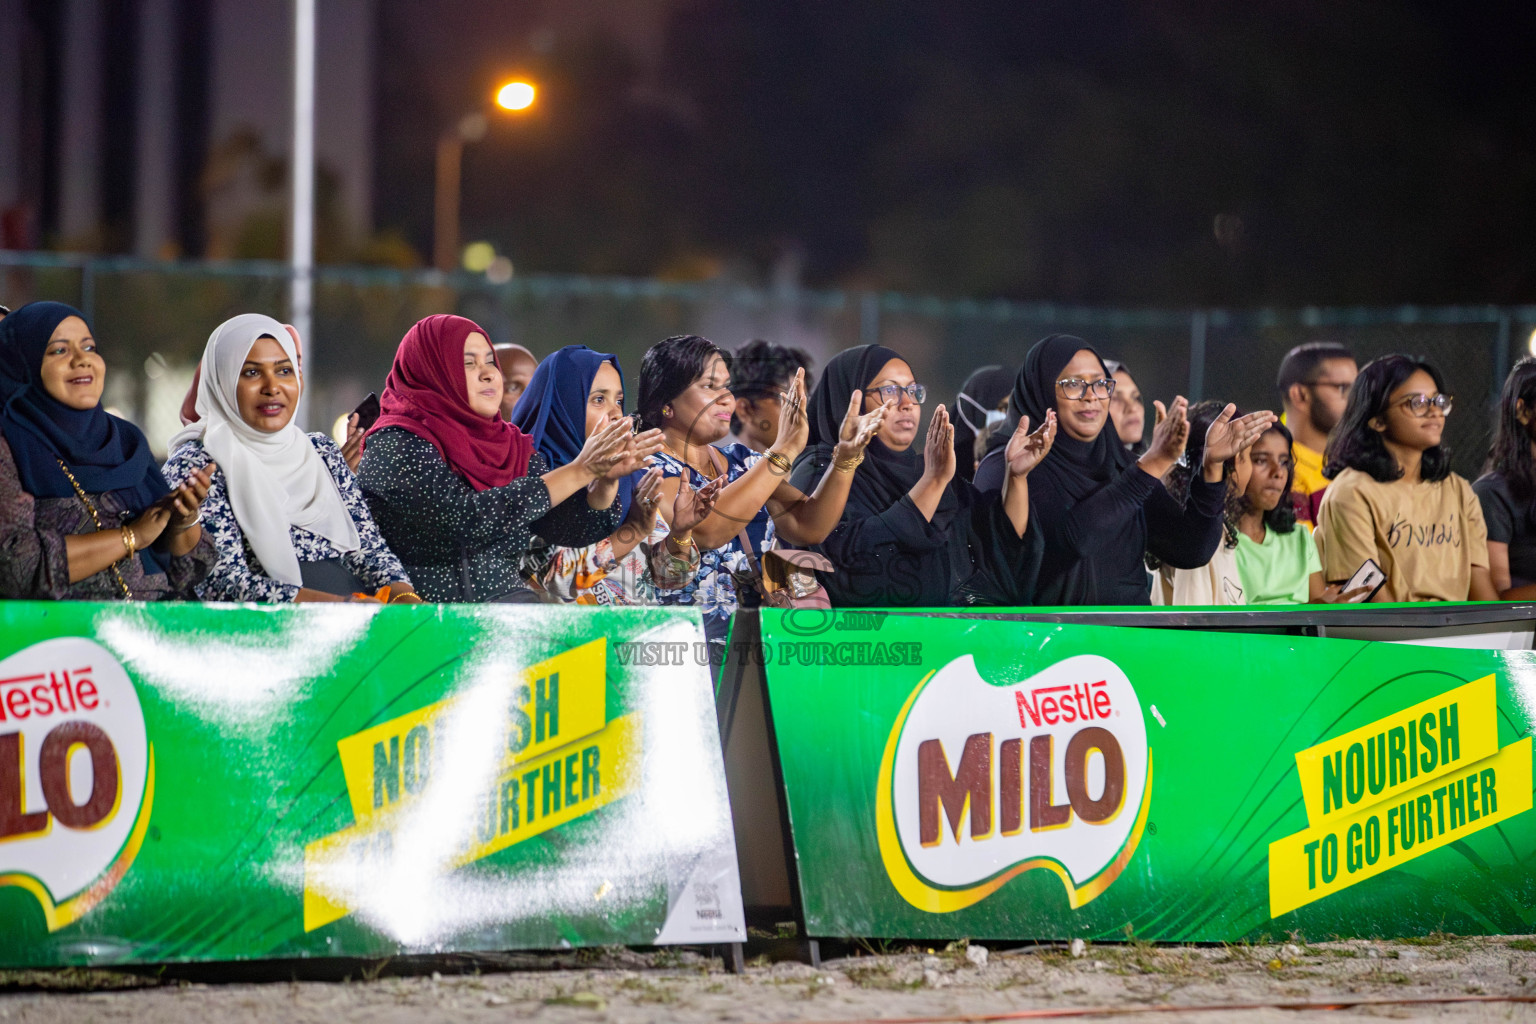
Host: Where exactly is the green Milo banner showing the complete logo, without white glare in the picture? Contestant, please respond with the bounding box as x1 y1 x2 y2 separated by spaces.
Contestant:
762 609 1536 941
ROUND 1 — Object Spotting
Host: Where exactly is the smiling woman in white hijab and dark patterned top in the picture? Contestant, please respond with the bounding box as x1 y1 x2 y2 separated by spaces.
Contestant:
164 313 419 602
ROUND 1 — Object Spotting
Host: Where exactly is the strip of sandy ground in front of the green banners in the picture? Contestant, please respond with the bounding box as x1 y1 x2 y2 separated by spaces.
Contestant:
0 936 1536 1024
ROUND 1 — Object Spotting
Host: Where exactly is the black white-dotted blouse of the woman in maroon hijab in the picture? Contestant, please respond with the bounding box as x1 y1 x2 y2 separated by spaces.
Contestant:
358 427 621 602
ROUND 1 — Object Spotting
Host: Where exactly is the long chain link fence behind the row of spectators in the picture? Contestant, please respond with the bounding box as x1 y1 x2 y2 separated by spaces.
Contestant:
0 252 1536 477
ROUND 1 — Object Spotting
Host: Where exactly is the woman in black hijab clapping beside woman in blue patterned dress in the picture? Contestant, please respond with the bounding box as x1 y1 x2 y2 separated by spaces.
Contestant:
790 345 1055 608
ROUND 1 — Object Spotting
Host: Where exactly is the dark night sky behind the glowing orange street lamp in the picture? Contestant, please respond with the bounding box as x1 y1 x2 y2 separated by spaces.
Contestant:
375 0 1536 306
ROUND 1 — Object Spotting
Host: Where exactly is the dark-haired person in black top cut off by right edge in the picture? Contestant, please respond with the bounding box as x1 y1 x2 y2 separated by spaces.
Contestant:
1471 356 1536 600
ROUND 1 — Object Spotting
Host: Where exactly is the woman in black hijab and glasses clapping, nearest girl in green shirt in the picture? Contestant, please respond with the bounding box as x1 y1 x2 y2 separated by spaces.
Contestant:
975 335 1275 605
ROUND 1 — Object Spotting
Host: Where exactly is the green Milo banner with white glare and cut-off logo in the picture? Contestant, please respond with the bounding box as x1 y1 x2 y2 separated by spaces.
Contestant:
0 602 745 966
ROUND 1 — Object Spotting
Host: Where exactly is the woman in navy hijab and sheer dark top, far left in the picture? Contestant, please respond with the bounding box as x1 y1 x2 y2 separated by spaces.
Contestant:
0 302 214 600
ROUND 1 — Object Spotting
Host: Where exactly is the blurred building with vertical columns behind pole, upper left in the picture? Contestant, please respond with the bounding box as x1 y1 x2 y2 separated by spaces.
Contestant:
0 0 378 258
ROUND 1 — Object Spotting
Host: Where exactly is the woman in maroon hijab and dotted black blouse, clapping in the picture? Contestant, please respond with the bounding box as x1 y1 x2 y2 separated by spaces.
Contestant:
358 315 660 602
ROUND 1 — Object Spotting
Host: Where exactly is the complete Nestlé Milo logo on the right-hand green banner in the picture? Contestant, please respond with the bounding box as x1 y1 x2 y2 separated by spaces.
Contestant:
879 656 1150 910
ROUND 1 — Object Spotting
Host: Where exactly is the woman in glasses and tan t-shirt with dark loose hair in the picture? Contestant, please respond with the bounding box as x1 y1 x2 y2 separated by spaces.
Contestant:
1316 355 1498 600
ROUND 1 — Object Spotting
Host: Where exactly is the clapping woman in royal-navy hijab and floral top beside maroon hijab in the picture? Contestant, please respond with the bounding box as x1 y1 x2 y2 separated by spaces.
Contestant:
511 345 719 605
